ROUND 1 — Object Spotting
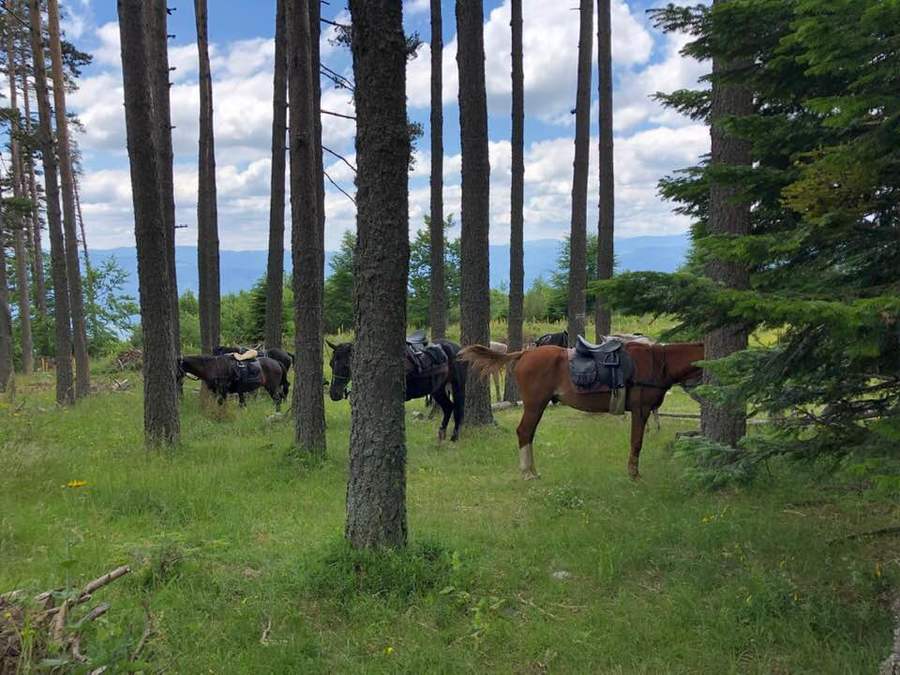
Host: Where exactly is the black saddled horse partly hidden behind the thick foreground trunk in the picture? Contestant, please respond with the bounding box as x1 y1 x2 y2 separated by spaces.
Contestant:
326 340 468 441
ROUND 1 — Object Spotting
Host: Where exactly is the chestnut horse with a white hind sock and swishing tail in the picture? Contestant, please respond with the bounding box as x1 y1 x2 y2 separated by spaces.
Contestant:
459 341 703 480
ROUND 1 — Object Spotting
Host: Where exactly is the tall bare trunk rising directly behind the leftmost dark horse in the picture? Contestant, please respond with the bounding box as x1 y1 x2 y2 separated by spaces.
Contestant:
194 0 221 354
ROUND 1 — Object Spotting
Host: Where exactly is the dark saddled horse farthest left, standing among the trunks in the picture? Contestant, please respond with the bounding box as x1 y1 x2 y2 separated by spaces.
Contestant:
177 355 287 410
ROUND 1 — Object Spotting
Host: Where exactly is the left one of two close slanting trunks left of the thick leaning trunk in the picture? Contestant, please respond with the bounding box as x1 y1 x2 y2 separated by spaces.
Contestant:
28 0 75 405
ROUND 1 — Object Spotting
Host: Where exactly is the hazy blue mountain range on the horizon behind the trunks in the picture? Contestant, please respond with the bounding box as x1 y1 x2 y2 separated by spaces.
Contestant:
91 234 690 297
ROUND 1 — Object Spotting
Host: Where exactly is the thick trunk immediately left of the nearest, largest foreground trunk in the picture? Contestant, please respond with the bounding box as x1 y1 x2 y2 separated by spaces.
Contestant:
285 0 325 457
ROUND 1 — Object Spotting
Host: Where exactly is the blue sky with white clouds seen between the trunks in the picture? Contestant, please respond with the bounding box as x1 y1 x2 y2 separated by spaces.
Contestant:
49 0 709 250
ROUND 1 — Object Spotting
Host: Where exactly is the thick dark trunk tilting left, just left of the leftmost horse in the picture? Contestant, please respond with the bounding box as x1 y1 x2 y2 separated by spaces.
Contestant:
118 0 179 446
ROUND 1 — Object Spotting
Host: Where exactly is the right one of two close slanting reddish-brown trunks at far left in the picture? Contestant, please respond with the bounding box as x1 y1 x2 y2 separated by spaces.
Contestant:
47 0 91 398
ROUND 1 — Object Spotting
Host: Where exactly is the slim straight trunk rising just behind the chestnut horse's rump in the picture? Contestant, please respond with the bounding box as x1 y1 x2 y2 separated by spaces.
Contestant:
503 0 525 403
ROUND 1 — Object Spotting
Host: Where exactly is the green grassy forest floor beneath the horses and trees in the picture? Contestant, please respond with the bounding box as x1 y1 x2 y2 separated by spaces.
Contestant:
0 360 900 673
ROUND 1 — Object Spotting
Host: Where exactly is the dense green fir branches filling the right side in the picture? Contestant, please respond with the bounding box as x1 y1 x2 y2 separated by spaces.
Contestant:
595 0 900 464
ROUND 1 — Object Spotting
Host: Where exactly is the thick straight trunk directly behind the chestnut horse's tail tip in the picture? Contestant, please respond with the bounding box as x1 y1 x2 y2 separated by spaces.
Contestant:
456 0 494 426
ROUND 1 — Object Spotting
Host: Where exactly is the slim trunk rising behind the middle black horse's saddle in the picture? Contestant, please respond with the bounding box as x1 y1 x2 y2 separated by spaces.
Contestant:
429 0 447 340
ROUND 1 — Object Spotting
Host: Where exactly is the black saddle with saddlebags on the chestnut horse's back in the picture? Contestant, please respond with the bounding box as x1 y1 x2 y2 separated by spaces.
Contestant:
569 335 634 415
